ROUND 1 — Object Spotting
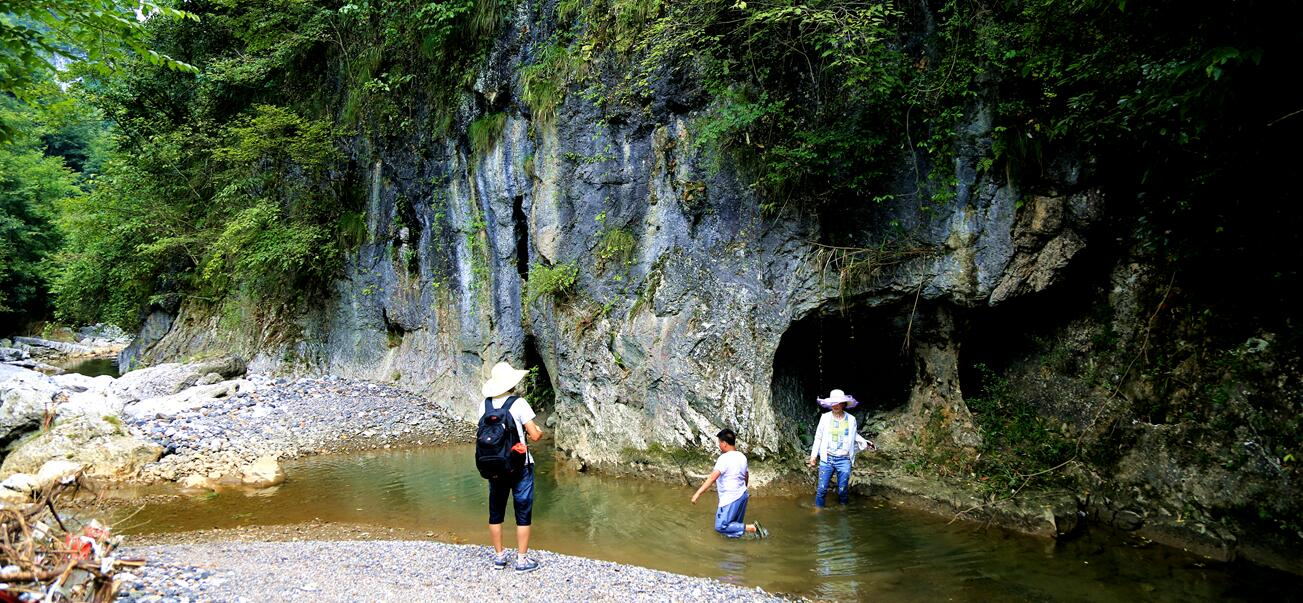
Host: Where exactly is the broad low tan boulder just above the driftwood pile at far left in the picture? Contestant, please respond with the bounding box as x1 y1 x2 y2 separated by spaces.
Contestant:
0 417 163 479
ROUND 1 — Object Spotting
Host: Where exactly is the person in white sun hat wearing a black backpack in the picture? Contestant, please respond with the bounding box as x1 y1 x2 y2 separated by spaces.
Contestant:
476 362 543 573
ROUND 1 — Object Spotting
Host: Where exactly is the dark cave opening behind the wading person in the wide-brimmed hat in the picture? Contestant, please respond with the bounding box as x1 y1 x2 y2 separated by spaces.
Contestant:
771 306 915 449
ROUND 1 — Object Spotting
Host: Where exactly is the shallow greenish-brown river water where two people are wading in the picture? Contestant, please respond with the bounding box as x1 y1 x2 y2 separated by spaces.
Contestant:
119 447 1300 602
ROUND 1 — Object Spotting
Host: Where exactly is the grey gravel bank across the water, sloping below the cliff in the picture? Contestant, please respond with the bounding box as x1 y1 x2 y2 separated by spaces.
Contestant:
128 375 472 481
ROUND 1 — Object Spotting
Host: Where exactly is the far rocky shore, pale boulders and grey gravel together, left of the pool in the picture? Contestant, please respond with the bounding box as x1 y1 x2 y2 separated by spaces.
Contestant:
0 357 472 504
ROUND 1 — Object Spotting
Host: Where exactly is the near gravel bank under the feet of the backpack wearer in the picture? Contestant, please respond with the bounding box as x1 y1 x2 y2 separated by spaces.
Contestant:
119 540 786 603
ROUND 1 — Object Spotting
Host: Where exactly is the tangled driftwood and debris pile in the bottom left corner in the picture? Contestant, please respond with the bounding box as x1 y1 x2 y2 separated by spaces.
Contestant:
0 477 143 603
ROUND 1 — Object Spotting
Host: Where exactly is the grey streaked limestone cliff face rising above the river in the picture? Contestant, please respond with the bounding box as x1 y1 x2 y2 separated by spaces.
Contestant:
130 8 1100 462
